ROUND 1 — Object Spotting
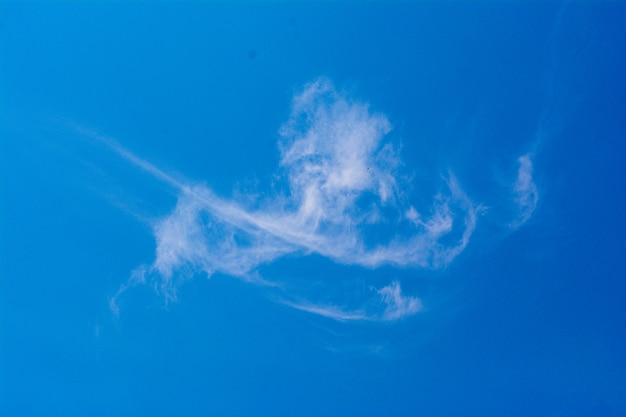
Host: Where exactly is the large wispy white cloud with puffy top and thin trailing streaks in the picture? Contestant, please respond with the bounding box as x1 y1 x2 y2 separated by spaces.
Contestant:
97 79 478 320
